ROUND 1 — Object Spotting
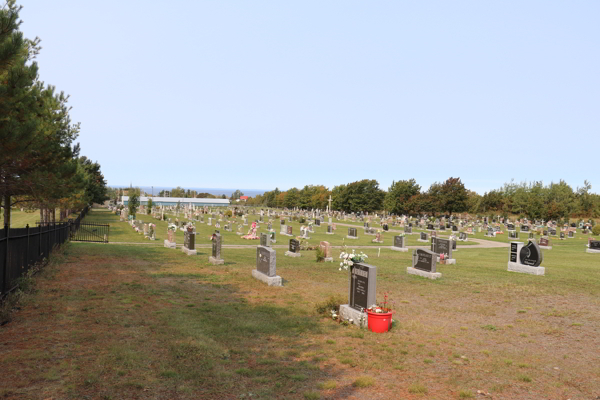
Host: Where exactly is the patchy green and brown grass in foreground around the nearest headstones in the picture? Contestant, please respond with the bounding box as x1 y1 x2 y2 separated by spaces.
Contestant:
0 210 600 400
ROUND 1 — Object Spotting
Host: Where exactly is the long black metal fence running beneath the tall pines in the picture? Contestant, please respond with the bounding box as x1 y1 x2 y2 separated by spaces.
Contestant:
0 207 88 298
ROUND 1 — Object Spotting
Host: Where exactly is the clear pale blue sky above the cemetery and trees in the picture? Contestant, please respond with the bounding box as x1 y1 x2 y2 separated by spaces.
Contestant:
21 0 600 194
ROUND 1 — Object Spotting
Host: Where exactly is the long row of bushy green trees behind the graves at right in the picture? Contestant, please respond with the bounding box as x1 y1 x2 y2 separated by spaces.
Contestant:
247 177 600 220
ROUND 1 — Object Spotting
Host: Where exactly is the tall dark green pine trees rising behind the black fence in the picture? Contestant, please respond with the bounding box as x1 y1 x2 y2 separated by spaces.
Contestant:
0 0 106 225
